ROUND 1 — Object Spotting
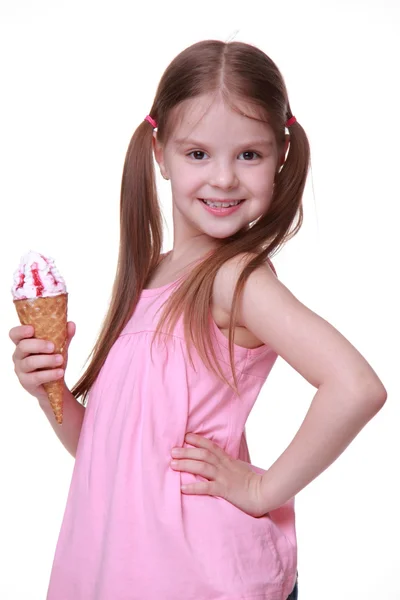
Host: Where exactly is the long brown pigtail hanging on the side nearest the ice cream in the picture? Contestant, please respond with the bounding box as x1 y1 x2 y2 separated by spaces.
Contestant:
72 121 162 402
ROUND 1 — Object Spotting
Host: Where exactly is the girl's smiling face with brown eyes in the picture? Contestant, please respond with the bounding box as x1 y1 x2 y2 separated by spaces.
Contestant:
154 95 279 241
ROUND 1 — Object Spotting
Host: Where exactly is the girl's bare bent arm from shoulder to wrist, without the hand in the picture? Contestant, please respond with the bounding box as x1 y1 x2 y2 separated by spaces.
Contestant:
214 258 387 510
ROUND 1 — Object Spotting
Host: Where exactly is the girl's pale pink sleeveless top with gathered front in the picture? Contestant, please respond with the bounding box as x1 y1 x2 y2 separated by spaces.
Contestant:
47 274 297 600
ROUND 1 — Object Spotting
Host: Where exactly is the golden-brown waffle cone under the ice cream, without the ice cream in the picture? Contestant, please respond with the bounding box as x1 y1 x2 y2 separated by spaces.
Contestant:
14 294 68 425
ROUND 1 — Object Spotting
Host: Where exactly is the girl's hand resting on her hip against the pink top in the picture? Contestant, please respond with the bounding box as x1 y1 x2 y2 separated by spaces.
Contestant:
171 433 267 517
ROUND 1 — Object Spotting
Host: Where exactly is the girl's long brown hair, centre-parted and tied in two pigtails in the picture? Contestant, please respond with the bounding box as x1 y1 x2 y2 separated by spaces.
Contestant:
72 40 310 402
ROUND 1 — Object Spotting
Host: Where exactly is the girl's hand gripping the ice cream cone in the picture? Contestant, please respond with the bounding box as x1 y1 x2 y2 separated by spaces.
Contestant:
9 321 76 401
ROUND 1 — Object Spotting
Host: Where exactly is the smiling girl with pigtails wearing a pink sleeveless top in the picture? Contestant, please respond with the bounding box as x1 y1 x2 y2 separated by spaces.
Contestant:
10 41 386 600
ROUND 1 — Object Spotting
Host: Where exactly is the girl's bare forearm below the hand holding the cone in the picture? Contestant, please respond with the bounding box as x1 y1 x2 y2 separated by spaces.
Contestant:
38 386 86 458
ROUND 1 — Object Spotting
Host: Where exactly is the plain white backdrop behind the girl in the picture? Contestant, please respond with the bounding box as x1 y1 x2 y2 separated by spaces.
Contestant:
0 0 400 600
